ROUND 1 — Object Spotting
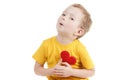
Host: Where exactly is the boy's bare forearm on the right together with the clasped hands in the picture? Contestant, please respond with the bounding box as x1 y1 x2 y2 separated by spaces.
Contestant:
55 62 95 78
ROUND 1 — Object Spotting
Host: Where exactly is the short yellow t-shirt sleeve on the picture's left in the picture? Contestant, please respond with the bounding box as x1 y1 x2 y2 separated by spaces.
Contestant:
32 42 46 64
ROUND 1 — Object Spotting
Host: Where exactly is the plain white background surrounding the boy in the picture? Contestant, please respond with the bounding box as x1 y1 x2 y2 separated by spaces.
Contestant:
0 0 120 80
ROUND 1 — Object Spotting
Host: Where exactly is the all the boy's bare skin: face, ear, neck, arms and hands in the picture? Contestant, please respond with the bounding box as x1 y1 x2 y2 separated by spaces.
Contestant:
34 6 94 78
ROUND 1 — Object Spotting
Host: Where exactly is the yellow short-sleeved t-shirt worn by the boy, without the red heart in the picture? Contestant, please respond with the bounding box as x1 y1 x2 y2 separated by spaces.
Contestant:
33 36 94 80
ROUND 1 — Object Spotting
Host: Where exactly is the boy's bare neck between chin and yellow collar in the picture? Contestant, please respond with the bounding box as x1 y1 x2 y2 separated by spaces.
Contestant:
57 34 74 44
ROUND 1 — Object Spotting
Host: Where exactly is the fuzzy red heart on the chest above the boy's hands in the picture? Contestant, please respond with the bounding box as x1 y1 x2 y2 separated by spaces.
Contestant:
61 51 76 65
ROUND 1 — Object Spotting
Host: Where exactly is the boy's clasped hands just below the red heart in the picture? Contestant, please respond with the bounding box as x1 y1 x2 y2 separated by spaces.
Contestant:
54 62 72 77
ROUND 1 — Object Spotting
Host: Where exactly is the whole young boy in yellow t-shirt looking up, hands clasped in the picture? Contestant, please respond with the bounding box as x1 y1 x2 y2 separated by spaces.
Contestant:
33 4 95 80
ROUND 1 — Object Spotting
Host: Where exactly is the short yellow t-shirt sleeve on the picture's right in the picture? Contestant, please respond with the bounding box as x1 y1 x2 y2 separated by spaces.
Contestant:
80 47 94 69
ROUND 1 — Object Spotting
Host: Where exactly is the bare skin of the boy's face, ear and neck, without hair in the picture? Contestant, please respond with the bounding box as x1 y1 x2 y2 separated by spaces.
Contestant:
56 6 84 44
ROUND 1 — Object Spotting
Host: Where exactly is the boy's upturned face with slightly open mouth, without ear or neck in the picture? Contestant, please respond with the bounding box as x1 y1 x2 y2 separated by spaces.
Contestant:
57 6 83 35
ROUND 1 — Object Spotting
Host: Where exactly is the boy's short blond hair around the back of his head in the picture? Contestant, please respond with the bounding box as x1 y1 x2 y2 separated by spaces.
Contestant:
72 4 92 39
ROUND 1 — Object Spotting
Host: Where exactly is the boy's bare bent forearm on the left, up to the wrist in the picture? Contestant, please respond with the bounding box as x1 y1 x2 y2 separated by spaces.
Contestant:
34 62 53 76
